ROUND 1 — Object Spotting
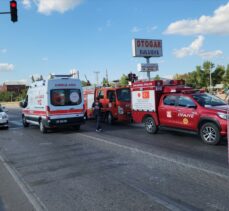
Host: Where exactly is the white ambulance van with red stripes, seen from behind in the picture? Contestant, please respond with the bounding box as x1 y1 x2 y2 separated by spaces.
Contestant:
20 75 84 133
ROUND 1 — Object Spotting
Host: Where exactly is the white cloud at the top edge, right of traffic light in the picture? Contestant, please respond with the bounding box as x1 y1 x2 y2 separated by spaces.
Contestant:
22 0 84 15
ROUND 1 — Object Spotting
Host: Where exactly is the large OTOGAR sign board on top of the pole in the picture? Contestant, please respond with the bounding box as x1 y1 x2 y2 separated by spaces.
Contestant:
132 39 162 58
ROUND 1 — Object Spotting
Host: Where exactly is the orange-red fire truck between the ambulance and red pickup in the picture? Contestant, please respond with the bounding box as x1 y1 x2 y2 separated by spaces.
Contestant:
83 86 131 124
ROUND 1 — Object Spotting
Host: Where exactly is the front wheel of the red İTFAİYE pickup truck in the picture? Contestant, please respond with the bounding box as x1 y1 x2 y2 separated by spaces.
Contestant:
200 122 220 145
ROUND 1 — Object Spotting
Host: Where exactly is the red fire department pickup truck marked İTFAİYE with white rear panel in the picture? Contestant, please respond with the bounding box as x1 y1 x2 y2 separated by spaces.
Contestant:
131 80 229 145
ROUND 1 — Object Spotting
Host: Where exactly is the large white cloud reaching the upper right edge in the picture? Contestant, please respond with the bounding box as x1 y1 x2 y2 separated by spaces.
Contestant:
164 2 229 35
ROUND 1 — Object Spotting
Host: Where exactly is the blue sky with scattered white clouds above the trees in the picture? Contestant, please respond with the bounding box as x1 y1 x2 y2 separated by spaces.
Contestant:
0 0 229 84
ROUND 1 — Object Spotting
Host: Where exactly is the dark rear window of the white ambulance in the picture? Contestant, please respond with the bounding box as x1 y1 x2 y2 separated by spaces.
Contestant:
51 89 82 106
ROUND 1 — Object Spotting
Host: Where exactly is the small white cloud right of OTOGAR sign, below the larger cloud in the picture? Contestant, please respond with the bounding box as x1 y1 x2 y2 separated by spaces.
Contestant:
173 35 223 59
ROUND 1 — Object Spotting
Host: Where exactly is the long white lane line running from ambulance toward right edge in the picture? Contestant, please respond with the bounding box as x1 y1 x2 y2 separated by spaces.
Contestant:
78 133 229 180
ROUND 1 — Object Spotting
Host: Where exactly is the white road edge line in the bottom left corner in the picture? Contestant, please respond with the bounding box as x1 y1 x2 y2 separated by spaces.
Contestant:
0 155 48 211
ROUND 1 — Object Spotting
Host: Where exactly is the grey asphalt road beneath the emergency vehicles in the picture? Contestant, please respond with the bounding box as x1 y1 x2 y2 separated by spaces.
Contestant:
0 109 229 211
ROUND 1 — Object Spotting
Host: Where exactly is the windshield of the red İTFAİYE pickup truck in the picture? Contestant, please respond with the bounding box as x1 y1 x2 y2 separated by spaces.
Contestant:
193 93 226 107
